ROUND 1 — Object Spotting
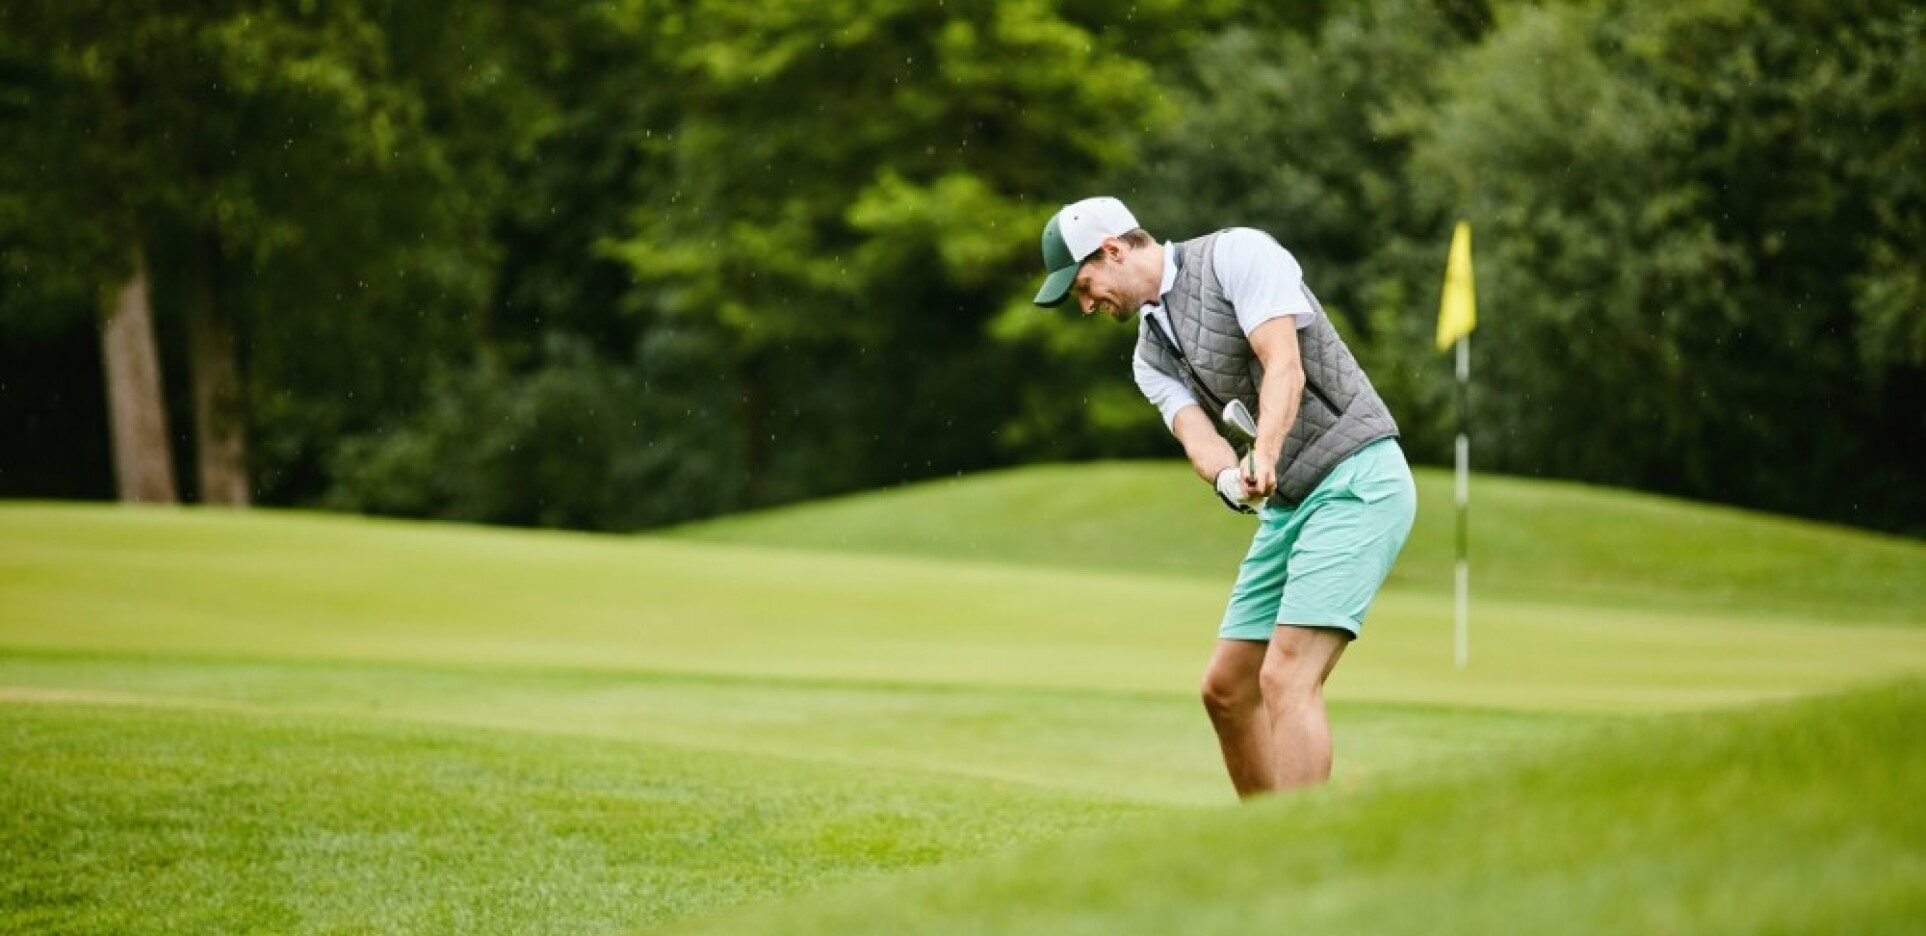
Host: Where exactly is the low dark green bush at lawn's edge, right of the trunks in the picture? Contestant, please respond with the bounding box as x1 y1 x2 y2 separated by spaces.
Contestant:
329 333 742 530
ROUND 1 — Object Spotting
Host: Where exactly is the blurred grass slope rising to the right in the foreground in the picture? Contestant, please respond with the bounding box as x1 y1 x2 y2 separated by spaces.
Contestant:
650 682 1926 936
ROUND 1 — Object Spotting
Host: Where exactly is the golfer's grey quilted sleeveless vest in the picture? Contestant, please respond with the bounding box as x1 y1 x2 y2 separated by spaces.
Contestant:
1136 231 1398 508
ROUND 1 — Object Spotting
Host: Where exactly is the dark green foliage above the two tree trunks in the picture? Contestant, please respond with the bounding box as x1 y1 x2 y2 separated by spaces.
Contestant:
6 4 496 299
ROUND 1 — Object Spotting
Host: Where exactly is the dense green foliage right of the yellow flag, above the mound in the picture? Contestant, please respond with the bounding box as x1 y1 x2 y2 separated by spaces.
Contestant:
1412 2 1922 522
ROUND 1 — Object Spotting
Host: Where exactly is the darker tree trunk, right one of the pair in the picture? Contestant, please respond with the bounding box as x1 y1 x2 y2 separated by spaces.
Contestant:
187 237 248 507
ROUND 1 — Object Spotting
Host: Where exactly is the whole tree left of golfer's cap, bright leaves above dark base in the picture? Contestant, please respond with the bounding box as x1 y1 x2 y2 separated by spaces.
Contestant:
600 0 1184 503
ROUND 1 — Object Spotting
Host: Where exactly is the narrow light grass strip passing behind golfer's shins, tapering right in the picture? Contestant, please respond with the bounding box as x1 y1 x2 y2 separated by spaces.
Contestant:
0 653 1591 805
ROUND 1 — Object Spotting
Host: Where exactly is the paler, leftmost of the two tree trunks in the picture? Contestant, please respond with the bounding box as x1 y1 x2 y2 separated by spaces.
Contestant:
100 239 181 505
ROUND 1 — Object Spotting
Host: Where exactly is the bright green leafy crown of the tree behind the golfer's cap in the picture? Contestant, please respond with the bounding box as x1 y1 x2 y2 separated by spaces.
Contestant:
622 2 1154 349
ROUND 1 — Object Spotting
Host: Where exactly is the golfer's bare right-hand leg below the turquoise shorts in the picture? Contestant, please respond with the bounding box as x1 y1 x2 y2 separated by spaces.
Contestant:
1258 626 1350 790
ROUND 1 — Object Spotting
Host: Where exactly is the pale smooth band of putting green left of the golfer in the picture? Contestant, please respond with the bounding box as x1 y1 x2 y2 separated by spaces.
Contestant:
0 507 1221 686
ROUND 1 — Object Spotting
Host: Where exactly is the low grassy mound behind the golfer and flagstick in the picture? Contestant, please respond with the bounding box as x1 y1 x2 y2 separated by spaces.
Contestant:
672 462 1926 626
